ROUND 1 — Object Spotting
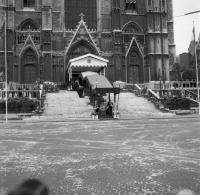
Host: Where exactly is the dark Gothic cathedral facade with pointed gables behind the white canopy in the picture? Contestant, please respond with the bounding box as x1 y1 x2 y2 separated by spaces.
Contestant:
0 0 175 83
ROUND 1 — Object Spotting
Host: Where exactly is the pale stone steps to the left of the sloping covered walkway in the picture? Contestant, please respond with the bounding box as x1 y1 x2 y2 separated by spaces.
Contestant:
28 90 93 121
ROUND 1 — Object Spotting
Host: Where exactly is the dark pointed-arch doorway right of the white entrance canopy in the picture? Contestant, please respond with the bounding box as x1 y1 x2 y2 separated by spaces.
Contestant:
127 49 143 83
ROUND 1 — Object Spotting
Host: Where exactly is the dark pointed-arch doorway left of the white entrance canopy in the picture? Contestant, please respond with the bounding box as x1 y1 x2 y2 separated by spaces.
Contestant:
21 48 39 84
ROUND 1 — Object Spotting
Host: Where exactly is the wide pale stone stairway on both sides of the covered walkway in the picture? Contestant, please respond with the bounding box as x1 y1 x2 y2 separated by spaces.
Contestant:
27 91 172 121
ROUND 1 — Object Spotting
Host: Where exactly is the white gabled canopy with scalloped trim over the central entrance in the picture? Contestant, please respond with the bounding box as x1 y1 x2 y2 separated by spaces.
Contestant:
67 54 108 81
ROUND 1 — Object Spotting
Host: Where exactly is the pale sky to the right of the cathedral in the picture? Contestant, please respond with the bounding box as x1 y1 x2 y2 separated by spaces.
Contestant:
172 0 200 55
